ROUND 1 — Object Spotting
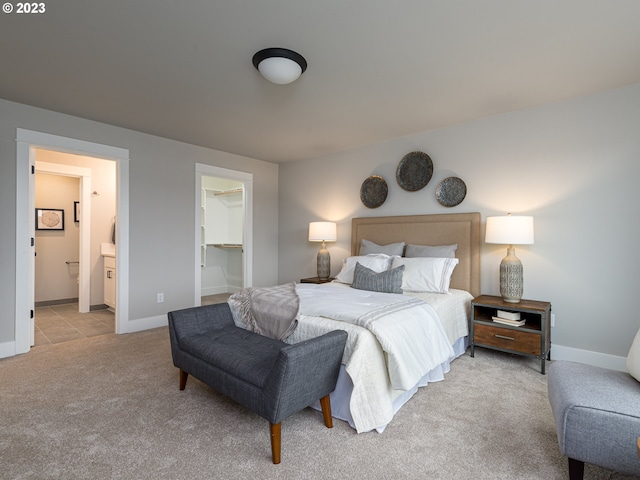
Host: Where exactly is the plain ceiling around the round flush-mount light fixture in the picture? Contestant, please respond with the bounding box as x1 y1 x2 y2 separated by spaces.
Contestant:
0 0 640 162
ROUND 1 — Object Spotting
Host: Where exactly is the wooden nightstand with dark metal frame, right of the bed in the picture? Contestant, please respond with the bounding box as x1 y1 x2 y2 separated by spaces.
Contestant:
471 295 551 375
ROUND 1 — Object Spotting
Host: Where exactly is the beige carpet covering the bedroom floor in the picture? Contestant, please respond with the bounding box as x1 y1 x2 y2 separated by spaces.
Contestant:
0 328 630 480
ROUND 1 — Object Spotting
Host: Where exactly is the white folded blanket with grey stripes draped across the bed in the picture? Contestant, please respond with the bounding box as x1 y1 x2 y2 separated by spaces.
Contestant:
296 284 453 390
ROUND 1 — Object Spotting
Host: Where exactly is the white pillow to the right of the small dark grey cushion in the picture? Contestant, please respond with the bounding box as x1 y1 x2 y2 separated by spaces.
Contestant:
391 257 459 293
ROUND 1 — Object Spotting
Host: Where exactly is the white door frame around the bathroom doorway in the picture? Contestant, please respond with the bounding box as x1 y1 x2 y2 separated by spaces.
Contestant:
14 128 129 354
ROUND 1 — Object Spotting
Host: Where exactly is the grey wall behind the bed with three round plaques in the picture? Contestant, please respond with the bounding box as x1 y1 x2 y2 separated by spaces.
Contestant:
279 84 640 357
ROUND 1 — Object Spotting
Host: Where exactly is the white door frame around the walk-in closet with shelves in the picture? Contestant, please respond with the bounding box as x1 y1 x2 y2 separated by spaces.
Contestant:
194 163 253 306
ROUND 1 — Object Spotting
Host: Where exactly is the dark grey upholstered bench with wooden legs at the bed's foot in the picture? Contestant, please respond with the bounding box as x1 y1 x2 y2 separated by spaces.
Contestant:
168 303 347 463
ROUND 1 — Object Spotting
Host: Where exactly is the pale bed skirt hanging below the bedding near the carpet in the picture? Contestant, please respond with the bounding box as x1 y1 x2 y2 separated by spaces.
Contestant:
311 337 469 433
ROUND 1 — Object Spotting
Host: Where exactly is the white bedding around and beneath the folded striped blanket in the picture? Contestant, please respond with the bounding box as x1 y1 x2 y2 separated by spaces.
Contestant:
287 282 472 433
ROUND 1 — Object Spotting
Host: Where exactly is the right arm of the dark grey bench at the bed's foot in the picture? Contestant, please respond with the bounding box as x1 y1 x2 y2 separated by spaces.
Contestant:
264 330 347 423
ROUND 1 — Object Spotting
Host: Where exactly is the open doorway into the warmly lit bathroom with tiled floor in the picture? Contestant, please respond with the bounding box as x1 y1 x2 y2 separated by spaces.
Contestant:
31 153 116 346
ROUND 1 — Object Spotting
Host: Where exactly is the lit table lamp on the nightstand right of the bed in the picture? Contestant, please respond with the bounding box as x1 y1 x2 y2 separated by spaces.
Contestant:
484 214 533 303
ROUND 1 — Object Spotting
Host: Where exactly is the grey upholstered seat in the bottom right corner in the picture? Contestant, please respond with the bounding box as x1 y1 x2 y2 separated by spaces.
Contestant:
548 361 640 480
